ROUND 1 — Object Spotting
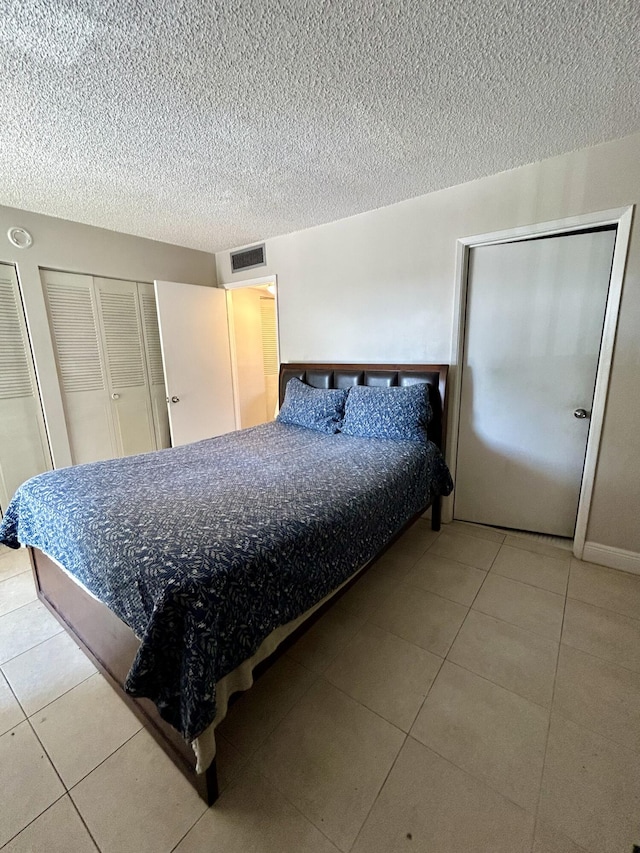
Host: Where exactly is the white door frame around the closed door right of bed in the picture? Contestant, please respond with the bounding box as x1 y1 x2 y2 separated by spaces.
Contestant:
443 205 634 559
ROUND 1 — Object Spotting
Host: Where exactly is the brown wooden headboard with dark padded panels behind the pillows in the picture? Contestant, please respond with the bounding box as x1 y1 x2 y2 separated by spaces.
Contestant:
279 362 449 450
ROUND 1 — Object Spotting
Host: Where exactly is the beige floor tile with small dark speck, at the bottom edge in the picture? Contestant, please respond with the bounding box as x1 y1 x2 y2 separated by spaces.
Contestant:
353 738 533 853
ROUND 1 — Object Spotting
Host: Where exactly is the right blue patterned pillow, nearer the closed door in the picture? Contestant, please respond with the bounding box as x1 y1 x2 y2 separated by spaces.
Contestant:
341 382 431 441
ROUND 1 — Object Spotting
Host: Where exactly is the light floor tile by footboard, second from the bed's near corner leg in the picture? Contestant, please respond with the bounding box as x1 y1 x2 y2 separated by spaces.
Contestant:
31 673 142 788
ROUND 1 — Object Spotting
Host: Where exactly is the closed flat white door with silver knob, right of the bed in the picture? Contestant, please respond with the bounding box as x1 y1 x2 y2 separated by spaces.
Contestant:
454 230 615 537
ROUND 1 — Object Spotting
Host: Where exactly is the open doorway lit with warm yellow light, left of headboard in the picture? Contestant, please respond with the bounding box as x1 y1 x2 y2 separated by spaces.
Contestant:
226 277 279 429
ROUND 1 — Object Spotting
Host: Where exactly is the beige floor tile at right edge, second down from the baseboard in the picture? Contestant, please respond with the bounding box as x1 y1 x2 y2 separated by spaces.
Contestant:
562 598 640 672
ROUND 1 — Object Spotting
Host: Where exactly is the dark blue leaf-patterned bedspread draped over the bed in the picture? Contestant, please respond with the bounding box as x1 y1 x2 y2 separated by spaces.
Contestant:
0 423 452 740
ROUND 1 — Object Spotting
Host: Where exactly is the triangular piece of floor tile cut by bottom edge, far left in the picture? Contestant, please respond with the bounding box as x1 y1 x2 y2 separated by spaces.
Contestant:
2 796 97 853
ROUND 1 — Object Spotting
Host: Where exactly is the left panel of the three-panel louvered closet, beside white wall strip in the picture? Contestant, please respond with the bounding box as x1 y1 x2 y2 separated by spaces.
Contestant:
42 270 119 465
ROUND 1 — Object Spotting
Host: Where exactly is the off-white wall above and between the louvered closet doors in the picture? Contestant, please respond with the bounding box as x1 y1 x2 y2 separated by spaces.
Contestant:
0 206 216 467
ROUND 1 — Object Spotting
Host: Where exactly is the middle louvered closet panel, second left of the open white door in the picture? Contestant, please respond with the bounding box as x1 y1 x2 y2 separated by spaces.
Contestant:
94 278 156 456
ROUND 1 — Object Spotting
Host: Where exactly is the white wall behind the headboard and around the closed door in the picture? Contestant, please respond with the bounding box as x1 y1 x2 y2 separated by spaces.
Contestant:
216 134 640 554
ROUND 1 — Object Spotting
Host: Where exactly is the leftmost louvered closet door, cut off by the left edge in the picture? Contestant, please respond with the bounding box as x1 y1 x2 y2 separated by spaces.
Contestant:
0 264 51 510
